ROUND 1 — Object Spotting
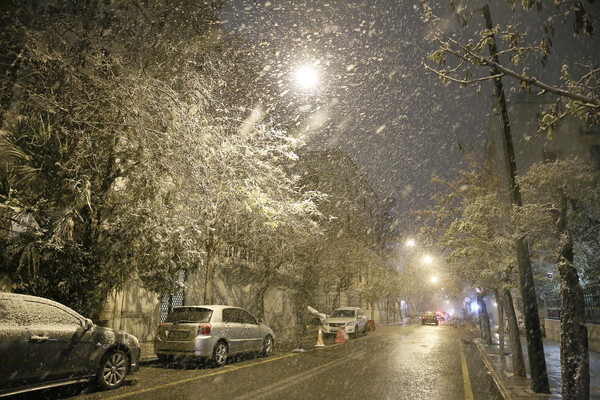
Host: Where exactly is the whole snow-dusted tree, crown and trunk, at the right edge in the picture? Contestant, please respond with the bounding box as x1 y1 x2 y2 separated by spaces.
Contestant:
519 158 600 399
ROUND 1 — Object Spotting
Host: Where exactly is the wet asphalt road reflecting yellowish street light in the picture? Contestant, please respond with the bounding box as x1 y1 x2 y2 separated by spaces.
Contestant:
21 324 502 400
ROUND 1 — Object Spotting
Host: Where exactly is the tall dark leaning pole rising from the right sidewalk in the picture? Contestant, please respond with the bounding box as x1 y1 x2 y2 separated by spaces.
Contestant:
483 4 550 393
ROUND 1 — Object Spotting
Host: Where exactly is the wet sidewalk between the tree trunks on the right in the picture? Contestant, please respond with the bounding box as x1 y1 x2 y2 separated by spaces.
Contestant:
474 335 600 400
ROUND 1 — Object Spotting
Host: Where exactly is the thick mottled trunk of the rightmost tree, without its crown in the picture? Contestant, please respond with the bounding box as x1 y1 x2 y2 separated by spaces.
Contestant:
557 195 590 400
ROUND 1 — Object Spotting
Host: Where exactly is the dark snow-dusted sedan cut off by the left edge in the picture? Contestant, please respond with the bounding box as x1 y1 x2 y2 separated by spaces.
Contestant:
0 292 140 396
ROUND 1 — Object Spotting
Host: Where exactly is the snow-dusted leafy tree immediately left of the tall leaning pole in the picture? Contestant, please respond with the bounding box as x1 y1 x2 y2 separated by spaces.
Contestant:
424 153 525 376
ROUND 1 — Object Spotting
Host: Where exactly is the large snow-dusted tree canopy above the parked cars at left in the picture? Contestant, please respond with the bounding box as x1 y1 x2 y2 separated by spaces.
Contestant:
0 0 324 316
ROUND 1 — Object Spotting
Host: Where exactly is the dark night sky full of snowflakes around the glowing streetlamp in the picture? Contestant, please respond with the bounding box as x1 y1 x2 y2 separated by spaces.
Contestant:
219 0 597 234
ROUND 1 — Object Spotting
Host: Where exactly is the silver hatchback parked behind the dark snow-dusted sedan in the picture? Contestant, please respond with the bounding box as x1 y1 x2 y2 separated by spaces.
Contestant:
154 305 275 367
